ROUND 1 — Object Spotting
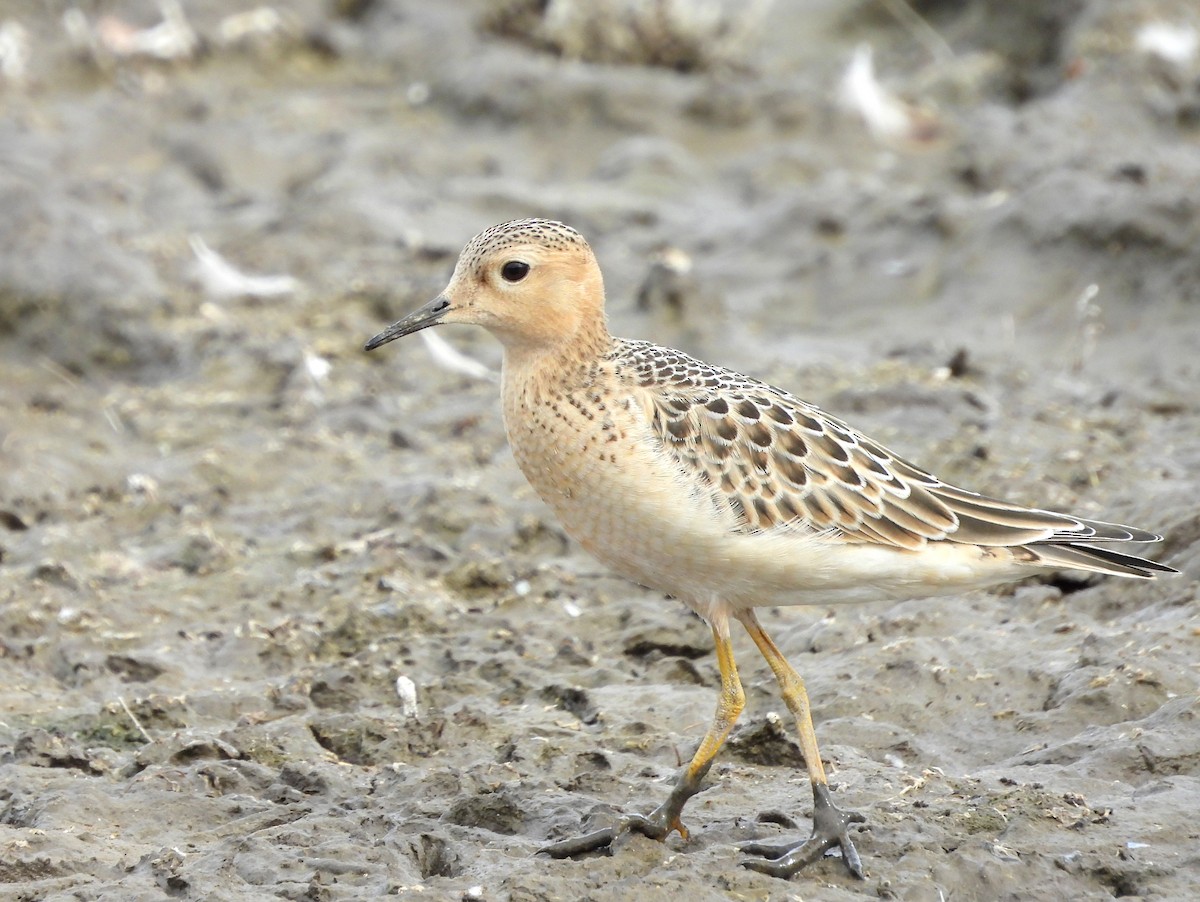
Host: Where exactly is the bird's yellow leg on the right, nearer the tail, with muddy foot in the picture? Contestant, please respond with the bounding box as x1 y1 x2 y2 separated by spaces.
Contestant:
737 609 866 879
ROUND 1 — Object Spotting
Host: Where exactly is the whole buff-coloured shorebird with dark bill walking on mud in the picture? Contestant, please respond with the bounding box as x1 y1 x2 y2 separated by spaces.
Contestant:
366 220 1175 878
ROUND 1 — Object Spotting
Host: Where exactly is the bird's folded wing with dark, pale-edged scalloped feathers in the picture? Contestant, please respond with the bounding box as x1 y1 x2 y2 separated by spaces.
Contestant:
623 342 1157 549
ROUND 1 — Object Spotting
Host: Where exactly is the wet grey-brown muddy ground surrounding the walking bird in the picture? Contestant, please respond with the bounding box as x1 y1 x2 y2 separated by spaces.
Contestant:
0 0 1200 902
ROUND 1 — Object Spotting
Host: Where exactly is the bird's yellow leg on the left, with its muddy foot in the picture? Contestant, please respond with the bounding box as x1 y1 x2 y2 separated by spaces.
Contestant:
538 614 745 858
